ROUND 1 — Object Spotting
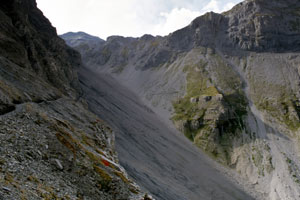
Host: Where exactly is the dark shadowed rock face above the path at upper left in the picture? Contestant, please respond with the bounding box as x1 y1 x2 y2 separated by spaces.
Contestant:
0 0 81 90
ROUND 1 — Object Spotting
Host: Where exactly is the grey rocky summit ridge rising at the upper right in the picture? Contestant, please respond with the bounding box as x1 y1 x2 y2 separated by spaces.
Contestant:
169 0 300 52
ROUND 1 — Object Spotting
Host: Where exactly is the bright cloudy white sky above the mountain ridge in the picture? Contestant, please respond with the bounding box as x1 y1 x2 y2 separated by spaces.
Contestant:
37 0 242 39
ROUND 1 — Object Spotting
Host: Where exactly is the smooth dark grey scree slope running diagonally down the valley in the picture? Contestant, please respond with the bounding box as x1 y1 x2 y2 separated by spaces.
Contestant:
79 69 254 200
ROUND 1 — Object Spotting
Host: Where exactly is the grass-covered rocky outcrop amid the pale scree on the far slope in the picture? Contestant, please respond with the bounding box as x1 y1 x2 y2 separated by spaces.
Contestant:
172 55 248 165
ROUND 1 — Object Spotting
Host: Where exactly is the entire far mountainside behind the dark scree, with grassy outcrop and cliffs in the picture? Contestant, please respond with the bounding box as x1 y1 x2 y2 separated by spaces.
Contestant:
62 0 300 200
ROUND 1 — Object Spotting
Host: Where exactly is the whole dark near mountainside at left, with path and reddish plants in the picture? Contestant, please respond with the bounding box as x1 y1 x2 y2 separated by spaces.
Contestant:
0 0 147 200
